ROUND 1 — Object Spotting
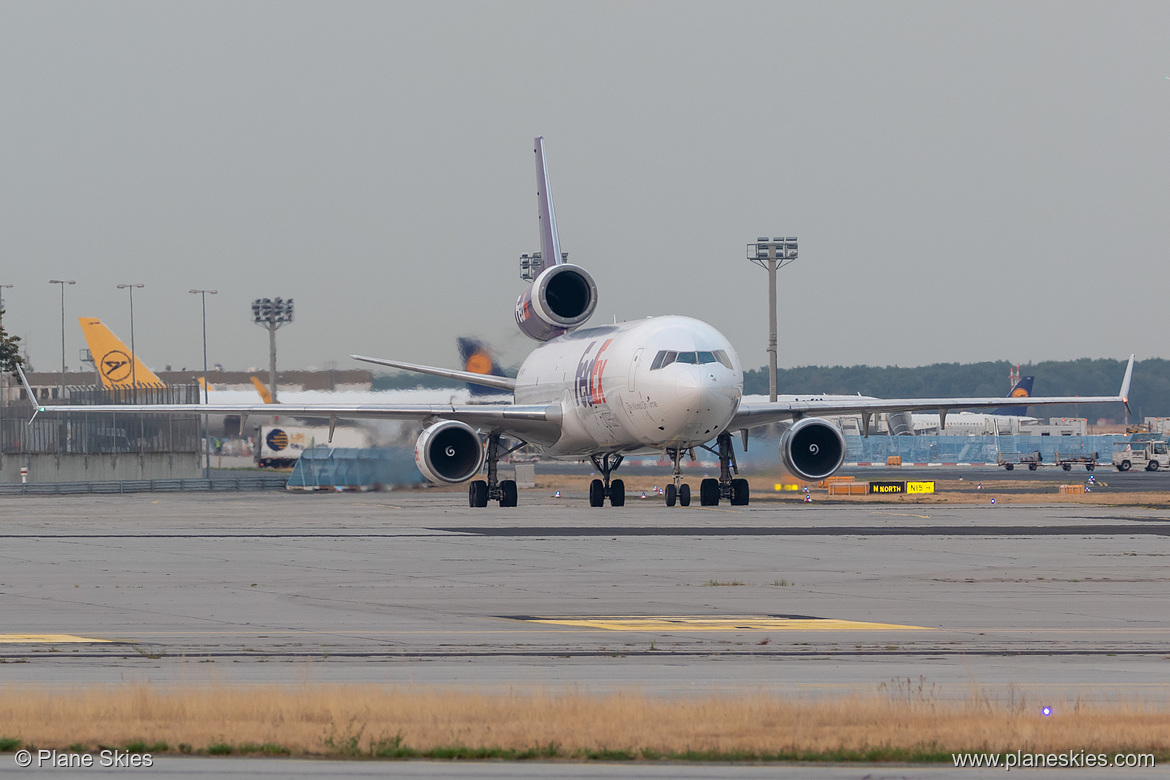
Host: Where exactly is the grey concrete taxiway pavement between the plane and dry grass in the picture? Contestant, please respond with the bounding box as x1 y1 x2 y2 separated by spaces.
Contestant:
0 490 1170 702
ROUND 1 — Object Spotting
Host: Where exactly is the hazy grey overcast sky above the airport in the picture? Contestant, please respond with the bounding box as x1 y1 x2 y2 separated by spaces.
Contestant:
0 0 1170 371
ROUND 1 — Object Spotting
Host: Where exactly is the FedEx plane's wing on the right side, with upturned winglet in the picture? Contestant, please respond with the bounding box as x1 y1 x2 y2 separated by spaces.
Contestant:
728 356 1134 430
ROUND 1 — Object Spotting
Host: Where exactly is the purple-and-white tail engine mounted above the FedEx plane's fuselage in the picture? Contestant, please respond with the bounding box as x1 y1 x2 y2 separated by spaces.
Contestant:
516 263 597 341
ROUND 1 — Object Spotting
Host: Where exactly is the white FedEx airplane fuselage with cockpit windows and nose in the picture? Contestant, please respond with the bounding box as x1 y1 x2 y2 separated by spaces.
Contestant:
515 316 743 456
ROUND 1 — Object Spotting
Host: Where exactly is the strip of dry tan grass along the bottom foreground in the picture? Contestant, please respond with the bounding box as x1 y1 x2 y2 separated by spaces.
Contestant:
0 681 1170 760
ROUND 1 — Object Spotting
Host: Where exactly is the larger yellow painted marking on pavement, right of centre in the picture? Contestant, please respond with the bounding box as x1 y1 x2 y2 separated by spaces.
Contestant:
525 615 935 631
